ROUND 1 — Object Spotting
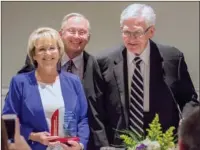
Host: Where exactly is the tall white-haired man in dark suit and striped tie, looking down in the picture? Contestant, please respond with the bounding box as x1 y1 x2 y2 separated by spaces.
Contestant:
93 4 197 146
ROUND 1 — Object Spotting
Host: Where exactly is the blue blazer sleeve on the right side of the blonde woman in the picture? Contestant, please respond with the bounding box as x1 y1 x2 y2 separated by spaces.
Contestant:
77 78 90 149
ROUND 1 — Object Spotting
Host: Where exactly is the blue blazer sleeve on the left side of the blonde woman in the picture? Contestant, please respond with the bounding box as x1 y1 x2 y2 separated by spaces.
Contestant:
3 77 33 141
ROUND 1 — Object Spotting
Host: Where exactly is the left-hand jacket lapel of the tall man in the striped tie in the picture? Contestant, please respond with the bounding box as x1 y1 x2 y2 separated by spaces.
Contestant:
113 46 129 125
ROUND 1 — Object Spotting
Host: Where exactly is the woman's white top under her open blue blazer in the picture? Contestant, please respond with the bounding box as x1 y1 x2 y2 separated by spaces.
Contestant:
38 76 84 150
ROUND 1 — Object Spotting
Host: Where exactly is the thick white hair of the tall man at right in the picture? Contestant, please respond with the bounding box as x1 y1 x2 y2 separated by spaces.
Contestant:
120 4 156 27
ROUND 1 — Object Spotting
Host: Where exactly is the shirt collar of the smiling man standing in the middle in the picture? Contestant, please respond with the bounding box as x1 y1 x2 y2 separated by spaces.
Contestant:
61 52 83 68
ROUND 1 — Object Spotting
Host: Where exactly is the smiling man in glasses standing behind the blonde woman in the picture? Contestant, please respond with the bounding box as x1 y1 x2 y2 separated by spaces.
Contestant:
15 13 101 150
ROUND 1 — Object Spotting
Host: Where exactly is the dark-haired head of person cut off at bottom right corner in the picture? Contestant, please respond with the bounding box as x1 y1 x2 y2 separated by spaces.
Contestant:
179 106 200 150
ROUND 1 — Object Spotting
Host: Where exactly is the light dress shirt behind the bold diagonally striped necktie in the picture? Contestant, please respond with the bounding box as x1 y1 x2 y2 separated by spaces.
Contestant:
127 42 150 112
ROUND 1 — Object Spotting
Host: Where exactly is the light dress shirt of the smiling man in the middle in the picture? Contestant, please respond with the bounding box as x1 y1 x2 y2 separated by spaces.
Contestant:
61 52 84 80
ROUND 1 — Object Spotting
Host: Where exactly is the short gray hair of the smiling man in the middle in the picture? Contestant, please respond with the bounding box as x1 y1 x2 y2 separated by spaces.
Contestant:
61 13 91 31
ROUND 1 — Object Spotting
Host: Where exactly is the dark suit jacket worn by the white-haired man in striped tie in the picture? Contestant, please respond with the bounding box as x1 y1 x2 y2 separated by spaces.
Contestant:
93 41 197 148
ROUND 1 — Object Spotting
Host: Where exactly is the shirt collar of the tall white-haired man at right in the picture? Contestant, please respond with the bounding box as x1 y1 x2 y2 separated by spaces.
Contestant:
127 41 150 65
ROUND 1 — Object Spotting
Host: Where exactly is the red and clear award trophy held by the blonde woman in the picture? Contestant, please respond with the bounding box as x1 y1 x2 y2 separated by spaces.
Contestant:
50 108 80 143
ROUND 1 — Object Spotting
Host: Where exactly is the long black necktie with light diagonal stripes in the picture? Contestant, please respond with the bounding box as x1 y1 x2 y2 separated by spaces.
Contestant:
129 57 144 137
